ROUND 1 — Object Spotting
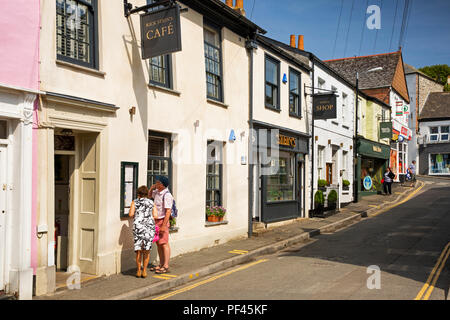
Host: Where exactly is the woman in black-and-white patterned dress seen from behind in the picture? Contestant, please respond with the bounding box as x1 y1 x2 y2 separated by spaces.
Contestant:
129 186 155 278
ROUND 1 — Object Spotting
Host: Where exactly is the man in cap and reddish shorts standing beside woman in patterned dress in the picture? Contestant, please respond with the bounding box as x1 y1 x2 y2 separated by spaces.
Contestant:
149 176 173 274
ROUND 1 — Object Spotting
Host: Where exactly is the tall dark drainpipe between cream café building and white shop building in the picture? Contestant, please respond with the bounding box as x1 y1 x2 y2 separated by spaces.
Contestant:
245 34 258 238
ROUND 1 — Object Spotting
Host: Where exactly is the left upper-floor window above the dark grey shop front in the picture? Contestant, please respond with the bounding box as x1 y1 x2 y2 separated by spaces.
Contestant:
265 56 280 110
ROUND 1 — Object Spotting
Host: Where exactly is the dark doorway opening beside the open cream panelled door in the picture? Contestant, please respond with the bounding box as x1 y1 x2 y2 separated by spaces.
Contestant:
54 152 75 271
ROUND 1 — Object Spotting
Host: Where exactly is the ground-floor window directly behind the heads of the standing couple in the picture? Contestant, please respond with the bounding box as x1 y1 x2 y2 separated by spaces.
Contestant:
147 133 172 186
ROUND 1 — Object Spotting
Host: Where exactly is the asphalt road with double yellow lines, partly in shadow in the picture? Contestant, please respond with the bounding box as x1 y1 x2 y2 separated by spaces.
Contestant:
147 179 450 300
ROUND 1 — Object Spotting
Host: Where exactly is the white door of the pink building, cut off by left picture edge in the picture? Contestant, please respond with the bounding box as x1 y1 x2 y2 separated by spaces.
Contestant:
0 145 7 293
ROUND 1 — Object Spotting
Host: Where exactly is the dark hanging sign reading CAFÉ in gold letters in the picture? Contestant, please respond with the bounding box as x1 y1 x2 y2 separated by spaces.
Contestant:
141 4 181 59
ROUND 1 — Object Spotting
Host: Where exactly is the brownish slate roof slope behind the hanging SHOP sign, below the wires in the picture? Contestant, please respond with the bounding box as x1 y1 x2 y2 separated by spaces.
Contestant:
324 51 401 89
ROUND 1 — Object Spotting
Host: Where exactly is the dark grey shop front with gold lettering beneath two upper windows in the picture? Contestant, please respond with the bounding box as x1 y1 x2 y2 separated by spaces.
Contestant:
256 121 309 223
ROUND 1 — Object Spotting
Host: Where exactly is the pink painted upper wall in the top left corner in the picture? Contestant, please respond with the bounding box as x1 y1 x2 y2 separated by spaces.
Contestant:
0 0 40 90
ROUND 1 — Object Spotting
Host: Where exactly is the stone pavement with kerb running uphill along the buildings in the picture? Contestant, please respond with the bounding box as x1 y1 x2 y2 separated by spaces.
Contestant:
34 182 423 300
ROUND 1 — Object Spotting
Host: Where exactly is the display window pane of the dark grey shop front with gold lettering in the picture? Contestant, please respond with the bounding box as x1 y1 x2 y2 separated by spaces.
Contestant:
266 151 295 202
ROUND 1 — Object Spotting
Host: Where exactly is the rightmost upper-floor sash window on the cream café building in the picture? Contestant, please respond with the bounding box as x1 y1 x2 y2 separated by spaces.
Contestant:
203 25 223 101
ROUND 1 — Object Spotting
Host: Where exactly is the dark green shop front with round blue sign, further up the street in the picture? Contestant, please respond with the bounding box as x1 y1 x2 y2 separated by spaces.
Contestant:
357 138 391 198
